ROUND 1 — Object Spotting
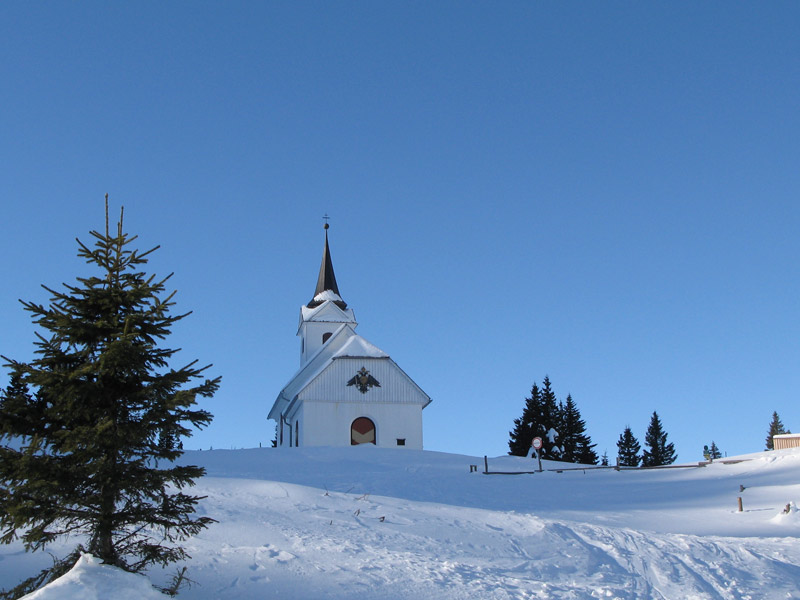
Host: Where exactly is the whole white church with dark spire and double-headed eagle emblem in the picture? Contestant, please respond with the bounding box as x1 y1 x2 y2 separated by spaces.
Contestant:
269 223 431 450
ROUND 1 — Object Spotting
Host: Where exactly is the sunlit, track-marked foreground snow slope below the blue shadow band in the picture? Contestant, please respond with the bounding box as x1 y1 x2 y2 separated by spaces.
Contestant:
178 464 800 600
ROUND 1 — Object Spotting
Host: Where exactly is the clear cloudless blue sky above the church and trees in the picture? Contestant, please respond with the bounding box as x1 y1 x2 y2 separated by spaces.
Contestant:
0 0 800 461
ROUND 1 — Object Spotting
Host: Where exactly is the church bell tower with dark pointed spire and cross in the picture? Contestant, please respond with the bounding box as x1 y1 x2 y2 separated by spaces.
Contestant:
297 223 358 367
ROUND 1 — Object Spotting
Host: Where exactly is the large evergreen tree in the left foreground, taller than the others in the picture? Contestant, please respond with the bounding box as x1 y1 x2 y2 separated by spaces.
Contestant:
0 196 219 594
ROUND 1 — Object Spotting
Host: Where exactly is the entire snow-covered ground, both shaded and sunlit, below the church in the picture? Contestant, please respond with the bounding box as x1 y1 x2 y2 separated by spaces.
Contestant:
0 446 800 600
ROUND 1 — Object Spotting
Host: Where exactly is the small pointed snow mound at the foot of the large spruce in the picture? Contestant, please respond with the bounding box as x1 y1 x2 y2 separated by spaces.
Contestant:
22 554 166 600
